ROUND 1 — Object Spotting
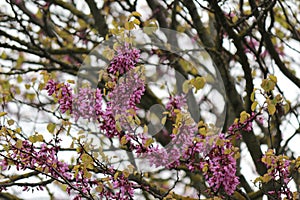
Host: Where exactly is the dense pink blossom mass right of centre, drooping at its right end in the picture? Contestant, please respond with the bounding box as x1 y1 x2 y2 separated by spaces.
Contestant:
131 95 239 195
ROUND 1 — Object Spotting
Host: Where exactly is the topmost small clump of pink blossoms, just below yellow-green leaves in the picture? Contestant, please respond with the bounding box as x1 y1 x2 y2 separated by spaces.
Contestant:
108 43 140 75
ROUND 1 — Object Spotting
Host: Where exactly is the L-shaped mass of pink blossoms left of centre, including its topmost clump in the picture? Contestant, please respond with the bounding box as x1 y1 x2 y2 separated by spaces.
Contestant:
45 44 145 138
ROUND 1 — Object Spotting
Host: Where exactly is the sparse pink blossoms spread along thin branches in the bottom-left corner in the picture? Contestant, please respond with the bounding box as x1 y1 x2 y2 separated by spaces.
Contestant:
0 135 134 200
